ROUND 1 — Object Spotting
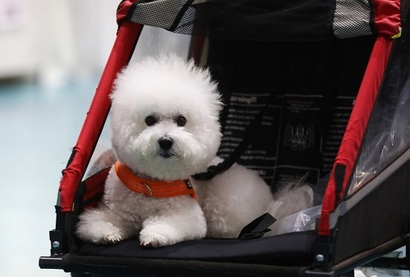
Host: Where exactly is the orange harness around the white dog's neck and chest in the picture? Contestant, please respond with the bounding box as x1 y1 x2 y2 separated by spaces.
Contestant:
115 161 196 199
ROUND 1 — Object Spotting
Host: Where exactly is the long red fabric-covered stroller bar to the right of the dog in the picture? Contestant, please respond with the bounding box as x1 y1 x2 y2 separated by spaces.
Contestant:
319 36 392 235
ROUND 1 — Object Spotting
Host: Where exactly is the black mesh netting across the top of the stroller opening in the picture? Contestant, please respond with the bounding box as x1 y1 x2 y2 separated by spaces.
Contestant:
132 0 369 41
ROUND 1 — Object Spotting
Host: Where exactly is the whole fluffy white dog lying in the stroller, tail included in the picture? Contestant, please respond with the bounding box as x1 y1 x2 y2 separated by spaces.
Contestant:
76 56 312 247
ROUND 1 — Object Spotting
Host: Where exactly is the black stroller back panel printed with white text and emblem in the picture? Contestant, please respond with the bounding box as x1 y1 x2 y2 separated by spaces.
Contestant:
218 93 352 187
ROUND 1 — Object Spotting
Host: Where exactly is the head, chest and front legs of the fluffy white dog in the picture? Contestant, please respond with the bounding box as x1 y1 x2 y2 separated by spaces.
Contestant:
76 56 222 247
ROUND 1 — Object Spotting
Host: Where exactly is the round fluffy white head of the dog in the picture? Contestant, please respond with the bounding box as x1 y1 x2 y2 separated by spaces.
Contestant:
111 56 222 181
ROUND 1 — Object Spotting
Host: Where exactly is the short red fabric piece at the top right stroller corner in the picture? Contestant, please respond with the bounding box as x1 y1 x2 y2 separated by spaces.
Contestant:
373 0 401 37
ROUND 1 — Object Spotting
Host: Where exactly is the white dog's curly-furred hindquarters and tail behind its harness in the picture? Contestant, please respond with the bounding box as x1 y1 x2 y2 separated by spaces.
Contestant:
194 158 313 238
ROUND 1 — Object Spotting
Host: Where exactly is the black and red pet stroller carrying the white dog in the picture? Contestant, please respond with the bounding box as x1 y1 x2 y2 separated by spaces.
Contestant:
40 0 410 277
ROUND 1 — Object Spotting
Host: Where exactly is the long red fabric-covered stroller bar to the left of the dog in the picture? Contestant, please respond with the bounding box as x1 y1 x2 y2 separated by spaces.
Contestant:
60 21 142 212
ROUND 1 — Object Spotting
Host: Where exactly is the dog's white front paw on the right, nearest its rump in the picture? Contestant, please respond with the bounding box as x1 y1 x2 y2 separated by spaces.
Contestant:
140 224 179 248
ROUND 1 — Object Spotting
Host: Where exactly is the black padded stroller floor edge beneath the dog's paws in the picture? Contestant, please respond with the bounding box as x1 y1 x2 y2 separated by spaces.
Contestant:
76 231 317 265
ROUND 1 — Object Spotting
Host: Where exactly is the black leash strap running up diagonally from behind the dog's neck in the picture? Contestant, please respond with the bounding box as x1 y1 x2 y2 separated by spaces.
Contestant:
192 110 264 181
